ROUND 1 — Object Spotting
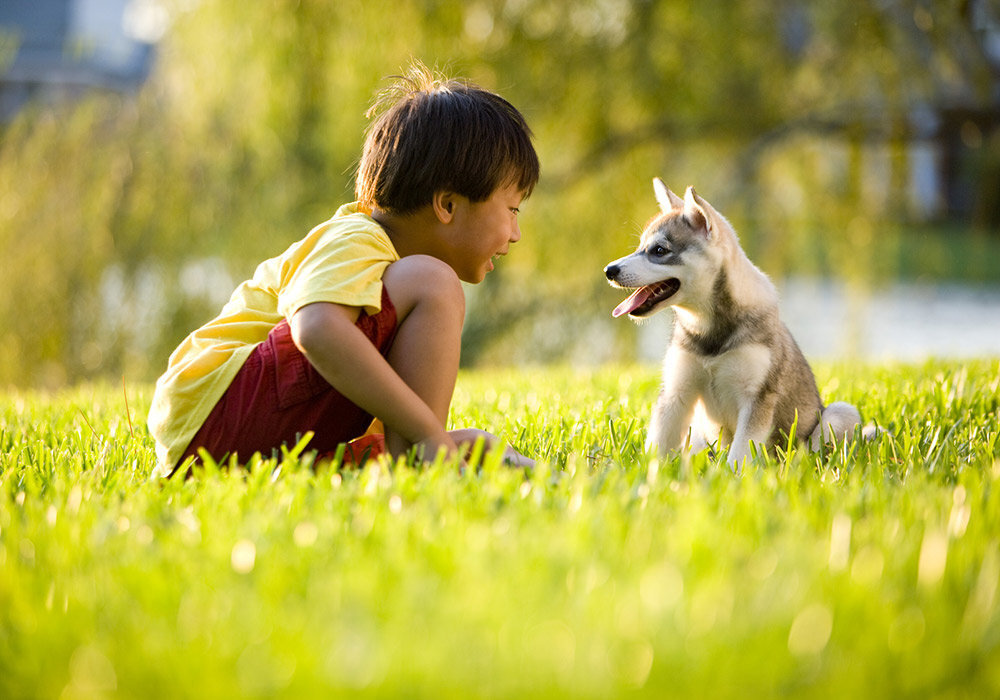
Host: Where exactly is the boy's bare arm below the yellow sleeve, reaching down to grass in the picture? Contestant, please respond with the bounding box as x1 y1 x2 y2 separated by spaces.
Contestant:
289 302 457 456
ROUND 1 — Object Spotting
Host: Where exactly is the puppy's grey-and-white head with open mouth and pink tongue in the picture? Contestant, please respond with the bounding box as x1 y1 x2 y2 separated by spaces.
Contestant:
604 178 722 319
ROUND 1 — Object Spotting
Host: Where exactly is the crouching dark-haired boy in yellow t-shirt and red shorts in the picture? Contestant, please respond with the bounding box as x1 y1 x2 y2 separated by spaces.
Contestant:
149 65 539 476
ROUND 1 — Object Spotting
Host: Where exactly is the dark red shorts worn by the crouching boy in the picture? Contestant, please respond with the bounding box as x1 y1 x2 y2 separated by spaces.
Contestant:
178 286 396 476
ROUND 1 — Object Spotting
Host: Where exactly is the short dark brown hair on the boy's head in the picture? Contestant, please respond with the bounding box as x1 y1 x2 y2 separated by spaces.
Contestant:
355 63 539 215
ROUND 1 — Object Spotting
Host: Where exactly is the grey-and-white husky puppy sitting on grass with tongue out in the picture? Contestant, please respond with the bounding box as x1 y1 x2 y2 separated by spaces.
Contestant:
604 178 861 465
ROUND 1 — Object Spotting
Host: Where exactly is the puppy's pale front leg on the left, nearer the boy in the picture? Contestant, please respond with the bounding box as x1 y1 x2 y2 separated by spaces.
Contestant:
646 345 700 455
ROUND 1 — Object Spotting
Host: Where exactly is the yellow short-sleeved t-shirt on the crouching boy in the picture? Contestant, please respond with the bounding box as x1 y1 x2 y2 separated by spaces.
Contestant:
148 202 399 476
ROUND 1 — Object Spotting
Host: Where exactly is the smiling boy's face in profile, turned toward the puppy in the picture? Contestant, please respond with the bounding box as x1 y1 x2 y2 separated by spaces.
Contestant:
445 184 523 284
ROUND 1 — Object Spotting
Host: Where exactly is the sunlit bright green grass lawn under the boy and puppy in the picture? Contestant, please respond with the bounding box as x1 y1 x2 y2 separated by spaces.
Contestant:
0 360 1000 698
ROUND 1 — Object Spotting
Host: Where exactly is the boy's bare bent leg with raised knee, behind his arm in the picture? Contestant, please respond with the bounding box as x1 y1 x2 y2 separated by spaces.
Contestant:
382 255 465 455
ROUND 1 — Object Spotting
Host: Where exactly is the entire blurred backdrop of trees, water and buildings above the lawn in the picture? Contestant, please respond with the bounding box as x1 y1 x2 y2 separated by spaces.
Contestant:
0 0 1000 387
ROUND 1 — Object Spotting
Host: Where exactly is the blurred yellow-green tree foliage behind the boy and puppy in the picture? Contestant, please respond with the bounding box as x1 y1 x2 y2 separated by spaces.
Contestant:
0 0 1000 384
